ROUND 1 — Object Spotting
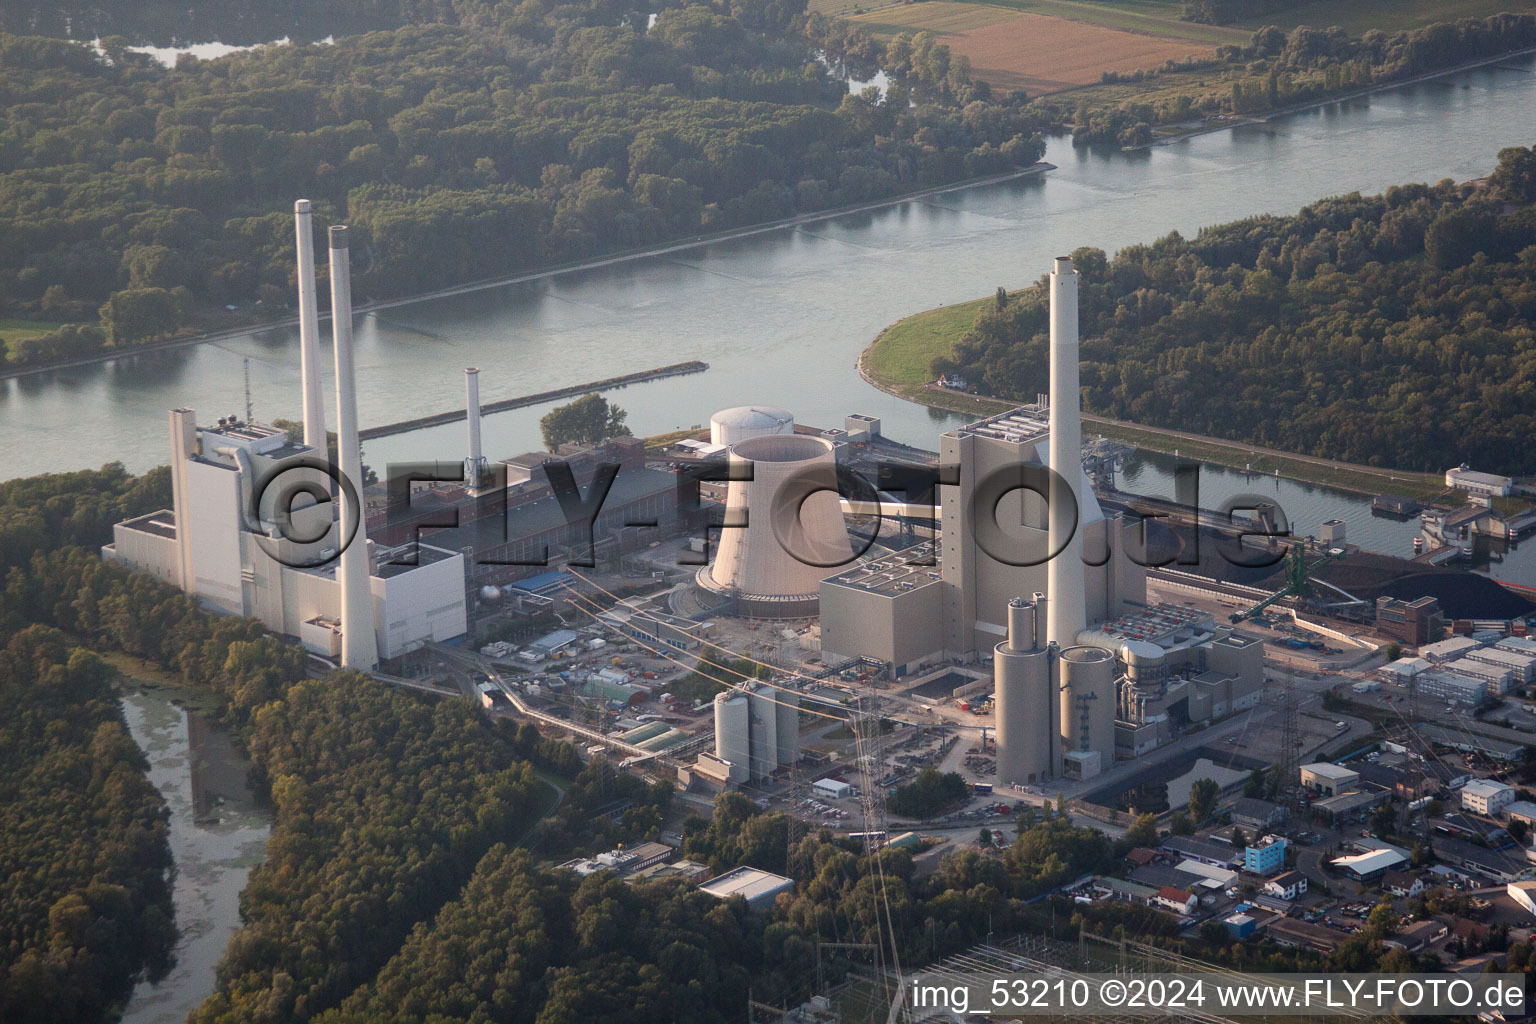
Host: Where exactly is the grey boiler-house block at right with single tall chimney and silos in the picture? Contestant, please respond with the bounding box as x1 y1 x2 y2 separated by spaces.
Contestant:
817 258 1264 785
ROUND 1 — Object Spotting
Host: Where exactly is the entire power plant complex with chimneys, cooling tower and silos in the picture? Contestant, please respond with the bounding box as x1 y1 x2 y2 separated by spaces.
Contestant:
103 228 1263 786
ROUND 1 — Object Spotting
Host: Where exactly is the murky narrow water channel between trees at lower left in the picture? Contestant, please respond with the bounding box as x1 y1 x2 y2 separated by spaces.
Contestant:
121 682 272 1024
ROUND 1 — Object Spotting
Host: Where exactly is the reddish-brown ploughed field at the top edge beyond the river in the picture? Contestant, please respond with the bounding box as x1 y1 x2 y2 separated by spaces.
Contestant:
851 2 1213 97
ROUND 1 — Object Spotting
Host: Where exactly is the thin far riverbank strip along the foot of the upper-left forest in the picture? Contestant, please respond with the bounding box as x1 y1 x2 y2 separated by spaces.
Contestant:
0 160 1055 381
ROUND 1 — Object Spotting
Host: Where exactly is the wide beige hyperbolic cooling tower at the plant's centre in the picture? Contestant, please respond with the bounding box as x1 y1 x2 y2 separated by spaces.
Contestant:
697 434 852 619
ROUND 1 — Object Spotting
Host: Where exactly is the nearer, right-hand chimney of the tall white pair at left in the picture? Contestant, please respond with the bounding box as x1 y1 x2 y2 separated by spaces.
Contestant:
330 224 379 672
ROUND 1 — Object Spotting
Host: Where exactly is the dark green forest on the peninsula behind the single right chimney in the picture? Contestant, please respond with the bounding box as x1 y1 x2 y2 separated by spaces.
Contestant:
932 147 1536 473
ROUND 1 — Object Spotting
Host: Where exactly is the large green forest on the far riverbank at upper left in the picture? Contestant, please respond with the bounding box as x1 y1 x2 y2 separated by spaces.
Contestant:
0 0 1043 365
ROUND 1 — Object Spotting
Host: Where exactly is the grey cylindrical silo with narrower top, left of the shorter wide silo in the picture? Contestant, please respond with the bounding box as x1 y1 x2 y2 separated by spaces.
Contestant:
992 594 1058 786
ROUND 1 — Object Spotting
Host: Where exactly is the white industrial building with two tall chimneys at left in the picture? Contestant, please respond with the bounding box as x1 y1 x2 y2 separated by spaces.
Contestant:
101 211 467 671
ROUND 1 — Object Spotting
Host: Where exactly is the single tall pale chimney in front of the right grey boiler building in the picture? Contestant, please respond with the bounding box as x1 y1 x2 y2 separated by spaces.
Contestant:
1046 256 1087 648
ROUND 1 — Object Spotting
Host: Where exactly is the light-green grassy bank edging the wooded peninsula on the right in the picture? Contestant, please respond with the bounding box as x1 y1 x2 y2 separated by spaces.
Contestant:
859 296 1445 500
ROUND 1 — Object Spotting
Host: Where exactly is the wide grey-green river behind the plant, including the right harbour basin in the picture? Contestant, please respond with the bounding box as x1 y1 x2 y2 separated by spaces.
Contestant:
9 57 1536 582
